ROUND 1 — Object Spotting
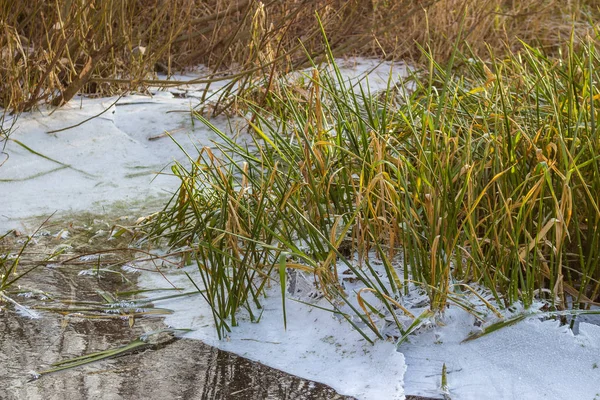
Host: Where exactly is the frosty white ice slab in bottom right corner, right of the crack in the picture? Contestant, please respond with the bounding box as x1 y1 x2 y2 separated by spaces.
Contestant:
401 309 600 400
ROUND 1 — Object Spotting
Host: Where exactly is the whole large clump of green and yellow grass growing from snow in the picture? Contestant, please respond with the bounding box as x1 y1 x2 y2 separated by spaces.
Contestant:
150 28 600 340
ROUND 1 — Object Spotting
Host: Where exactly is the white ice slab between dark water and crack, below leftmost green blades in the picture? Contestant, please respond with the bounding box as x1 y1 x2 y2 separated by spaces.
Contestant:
139 267 405 400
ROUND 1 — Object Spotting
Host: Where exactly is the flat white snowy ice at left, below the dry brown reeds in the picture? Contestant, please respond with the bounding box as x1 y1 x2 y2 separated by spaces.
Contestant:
0 93 239 231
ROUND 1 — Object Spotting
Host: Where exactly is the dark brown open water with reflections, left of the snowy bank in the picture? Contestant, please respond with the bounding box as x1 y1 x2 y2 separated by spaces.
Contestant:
0 222 434 400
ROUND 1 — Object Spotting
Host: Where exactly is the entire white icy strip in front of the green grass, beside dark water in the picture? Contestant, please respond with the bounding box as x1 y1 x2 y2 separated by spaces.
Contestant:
138 256 600 400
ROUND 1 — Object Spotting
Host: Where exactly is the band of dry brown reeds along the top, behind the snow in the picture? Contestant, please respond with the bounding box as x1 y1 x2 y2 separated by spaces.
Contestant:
0 0 600 111
